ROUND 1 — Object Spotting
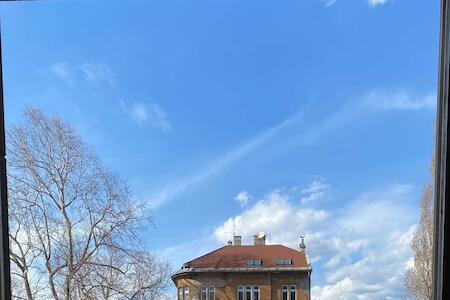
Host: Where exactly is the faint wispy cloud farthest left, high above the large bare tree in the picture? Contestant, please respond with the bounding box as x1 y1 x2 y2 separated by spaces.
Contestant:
47 62 115 87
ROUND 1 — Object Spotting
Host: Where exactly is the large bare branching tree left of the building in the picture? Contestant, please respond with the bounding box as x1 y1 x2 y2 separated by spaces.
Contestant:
7 108 169 300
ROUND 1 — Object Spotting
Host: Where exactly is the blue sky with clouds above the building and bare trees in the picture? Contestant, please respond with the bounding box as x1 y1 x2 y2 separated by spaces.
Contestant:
0 0 439 300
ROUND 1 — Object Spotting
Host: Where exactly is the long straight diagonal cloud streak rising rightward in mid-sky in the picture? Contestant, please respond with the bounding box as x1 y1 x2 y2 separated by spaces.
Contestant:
148 115 299 207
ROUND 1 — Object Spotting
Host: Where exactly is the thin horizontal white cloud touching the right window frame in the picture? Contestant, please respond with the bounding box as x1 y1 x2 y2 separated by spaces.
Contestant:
362 90 437 111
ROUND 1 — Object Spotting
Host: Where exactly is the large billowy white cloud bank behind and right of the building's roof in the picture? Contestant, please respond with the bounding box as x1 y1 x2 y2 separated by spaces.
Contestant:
214 184 416 300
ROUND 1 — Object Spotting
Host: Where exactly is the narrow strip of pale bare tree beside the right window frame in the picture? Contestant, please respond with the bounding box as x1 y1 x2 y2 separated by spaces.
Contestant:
405 155 435 300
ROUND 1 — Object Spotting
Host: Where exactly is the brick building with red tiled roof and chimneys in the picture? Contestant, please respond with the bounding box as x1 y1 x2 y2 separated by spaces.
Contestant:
172 233 312 300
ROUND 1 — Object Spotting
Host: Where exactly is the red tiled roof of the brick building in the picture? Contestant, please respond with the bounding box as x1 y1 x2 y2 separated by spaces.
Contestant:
186 245 308 268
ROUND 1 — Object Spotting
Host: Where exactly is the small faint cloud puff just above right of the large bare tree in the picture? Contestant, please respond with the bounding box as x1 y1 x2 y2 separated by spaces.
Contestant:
129 102 171 131
